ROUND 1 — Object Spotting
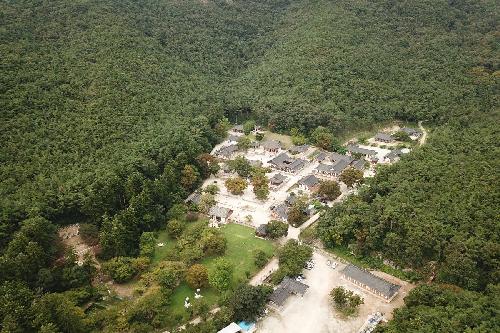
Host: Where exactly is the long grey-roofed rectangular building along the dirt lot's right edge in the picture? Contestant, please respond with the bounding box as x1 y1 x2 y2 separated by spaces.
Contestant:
340 264 401 302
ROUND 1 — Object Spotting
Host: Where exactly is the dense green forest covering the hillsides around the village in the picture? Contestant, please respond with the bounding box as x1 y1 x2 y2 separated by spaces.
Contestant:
0 0 500 332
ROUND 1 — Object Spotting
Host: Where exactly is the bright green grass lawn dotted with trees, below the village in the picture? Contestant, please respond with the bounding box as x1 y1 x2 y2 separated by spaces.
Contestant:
159 224 275 321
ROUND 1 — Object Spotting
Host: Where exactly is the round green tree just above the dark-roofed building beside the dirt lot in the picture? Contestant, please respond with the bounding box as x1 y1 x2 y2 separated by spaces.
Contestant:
278 239 312 276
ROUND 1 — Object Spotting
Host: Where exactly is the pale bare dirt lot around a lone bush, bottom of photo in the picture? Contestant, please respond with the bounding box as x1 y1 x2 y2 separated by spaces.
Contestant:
257 251 414 333
